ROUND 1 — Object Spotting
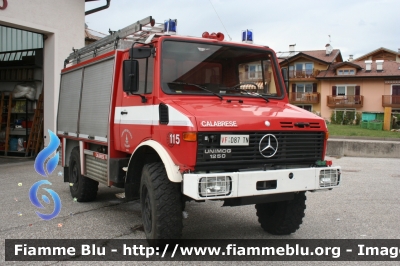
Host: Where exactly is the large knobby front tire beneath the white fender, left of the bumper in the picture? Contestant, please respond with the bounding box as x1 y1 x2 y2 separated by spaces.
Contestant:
140 162 183 246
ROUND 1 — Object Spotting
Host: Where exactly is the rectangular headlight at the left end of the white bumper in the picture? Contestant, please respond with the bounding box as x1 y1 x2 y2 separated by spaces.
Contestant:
199 176 232 197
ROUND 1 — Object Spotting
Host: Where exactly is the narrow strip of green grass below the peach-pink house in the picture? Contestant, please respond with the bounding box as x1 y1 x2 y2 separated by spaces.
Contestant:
328 124 400 139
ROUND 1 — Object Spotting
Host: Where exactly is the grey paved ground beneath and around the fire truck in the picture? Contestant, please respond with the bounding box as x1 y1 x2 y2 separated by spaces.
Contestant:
0 157 400 265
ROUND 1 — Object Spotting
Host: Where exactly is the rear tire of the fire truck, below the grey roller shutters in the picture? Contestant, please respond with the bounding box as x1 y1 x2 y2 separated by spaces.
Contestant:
69 147 99 202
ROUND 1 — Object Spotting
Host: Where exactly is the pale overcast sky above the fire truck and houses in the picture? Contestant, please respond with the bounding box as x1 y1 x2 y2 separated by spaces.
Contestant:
86 0 400 61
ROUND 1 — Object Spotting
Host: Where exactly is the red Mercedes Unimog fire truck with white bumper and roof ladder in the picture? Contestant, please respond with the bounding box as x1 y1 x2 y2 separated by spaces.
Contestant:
57 17 341 243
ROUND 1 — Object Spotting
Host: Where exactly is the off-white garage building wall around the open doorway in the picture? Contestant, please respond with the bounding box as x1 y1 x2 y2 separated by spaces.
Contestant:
0 0 85 146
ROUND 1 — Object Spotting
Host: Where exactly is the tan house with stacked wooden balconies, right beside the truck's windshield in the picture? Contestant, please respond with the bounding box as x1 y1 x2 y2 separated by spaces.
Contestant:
280 44 343 114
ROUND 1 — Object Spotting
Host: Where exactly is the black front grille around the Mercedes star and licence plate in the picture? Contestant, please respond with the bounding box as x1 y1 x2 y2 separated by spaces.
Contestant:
196 132 325 170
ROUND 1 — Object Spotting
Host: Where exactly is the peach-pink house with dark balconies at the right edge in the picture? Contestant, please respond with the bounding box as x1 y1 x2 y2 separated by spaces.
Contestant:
316 48 400 130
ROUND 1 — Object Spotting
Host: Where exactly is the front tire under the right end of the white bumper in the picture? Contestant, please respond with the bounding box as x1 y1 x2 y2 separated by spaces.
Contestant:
256 191 306 235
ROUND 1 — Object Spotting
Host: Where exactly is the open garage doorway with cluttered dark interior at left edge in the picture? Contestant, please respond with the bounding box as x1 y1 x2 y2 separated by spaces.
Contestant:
0 25 44 157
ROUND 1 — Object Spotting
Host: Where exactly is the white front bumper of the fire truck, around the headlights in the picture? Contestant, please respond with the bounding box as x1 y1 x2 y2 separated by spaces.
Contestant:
183 166 341 200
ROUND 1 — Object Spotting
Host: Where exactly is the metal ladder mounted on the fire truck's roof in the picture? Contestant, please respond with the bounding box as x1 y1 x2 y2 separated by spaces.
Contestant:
64 16 164 67
